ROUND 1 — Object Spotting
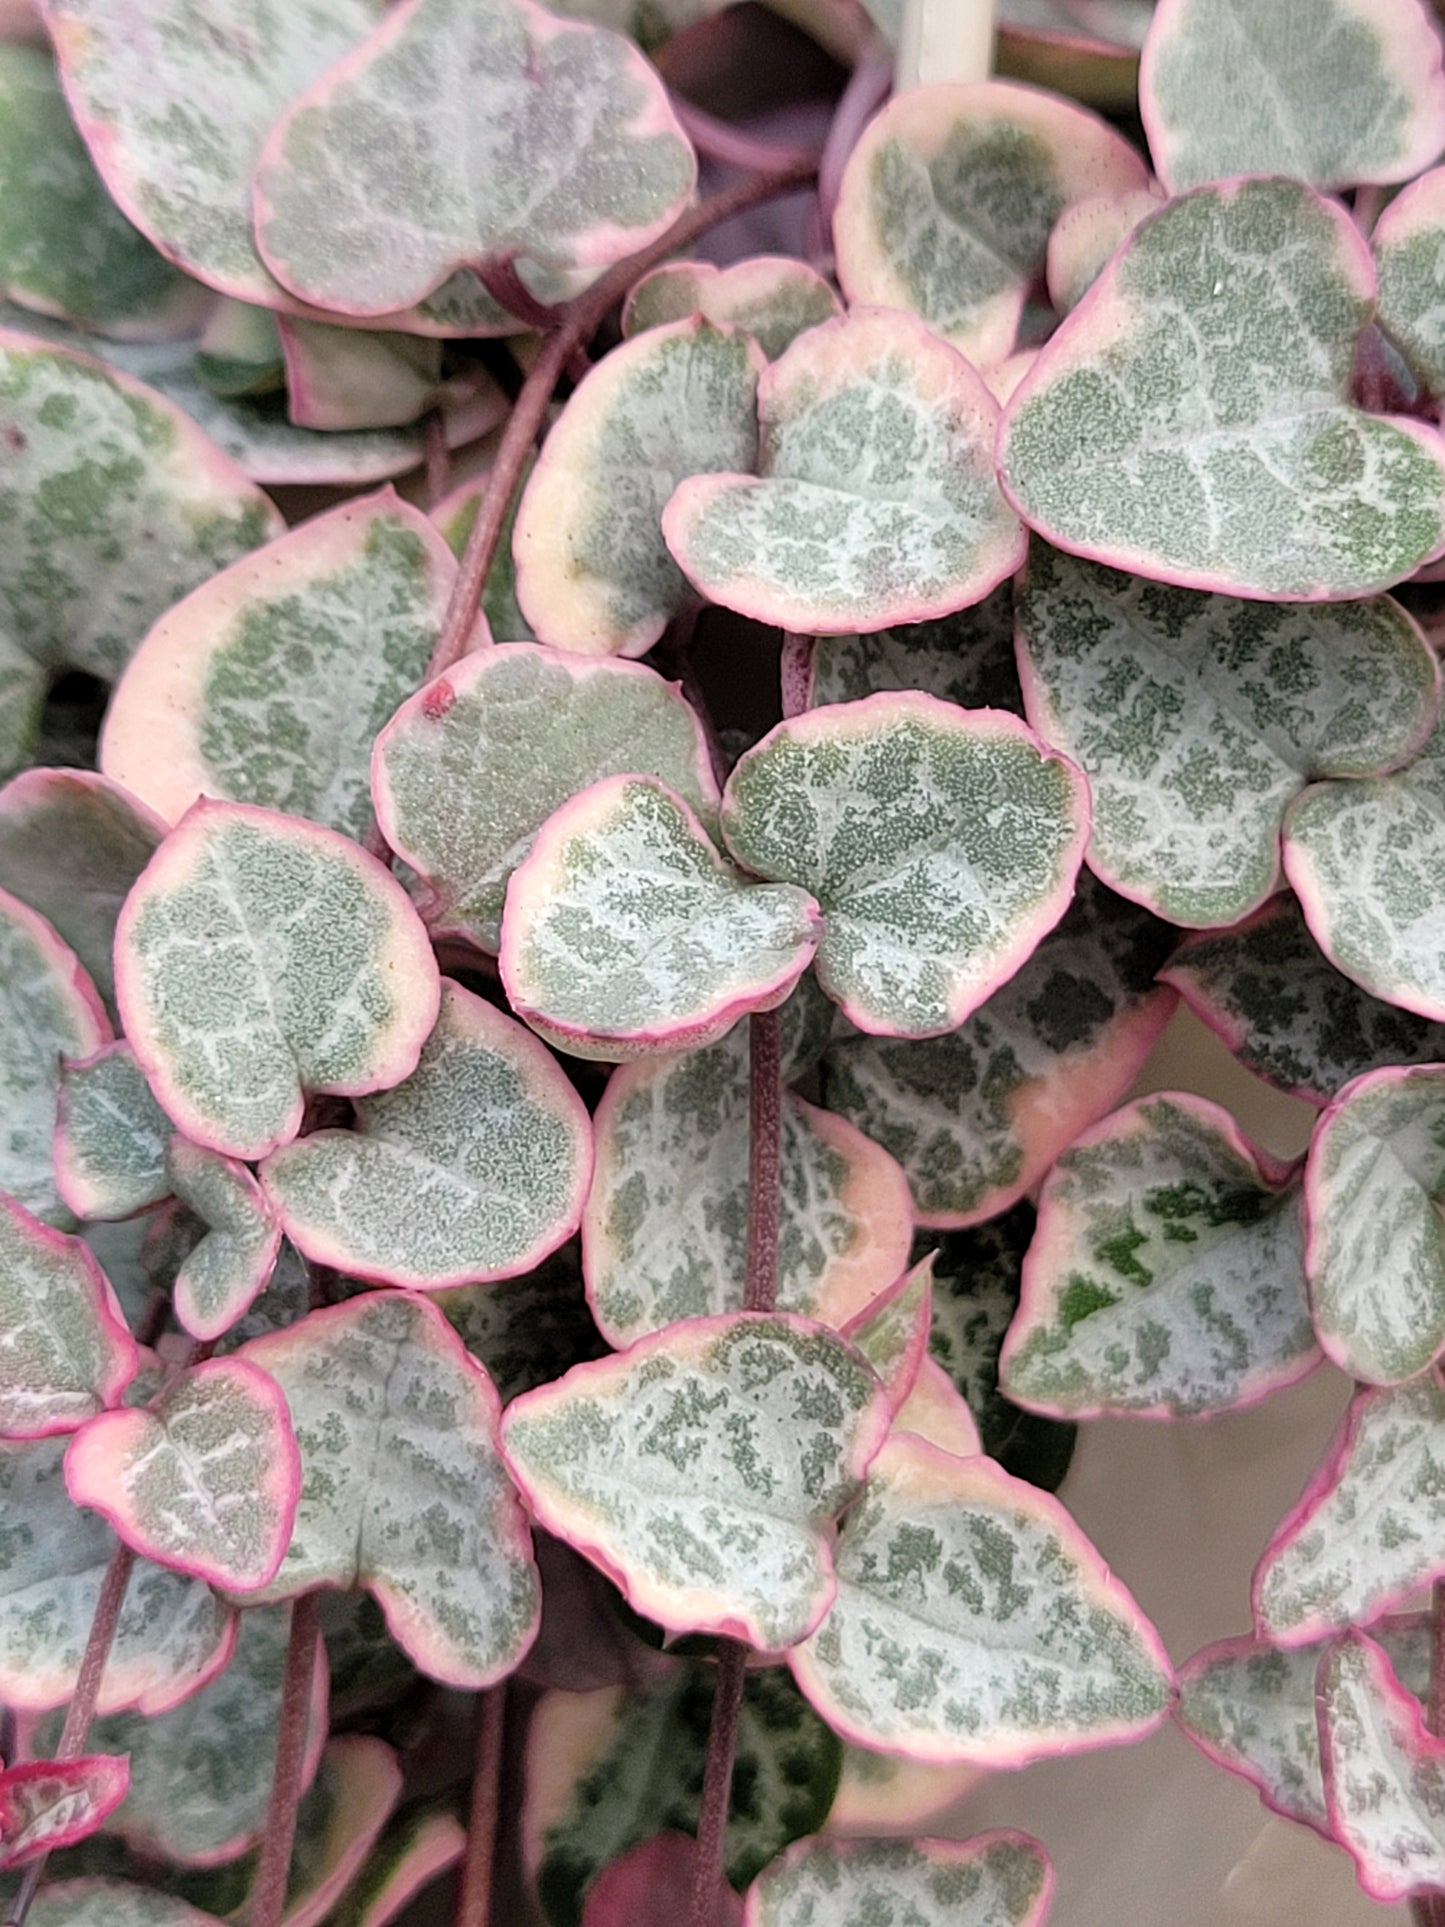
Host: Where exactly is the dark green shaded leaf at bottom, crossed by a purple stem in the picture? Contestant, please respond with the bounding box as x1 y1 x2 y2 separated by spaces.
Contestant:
522 1659 842 1927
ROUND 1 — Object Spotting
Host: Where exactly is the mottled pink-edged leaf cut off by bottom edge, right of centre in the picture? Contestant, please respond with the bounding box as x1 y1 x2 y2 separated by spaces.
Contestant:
742 1829 1054 1927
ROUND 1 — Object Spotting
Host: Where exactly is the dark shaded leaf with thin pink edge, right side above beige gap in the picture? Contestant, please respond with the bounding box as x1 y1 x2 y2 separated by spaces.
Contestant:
1160 892 1445 1108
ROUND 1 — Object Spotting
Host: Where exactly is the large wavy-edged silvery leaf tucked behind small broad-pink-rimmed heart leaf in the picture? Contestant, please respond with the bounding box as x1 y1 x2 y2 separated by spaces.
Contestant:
241 1291 539 1688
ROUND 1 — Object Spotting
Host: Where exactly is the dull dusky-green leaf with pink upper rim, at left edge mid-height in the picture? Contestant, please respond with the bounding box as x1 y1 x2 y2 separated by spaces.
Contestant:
0 769 166 1006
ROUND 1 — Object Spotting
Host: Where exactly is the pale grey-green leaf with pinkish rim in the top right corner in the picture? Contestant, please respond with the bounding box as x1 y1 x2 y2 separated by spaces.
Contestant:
1139 0 1445 195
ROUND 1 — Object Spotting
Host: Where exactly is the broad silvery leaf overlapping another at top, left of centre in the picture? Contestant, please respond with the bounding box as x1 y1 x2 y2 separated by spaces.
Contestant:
256 0 696 316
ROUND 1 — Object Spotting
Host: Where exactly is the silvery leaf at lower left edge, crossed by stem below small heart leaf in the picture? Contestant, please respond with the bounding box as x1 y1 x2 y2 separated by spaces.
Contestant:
0 1438 237 1718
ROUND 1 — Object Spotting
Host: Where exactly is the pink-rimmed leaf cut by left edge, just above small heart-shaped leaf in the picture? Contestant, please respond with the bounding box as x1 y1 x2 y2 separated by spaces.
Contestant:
0 1195 139 1439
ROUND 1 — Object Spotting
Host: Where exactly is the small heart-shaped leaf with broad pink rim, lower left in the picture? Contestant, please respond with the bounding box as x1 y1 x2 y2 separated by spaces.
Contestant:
66 1359 301 1592
